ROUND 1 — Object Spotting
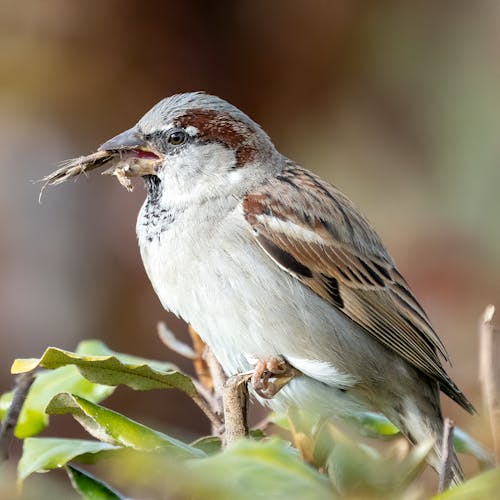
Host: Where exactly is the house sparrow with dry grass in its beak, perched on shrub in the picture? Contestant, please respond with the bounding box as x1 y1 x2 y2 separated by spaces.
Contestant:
65 92 474 480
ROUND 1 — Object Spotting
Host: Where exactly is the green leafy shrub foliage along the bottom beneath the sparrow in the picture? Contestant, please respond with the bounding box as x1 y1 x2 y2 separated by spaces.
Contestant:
0 341 500 500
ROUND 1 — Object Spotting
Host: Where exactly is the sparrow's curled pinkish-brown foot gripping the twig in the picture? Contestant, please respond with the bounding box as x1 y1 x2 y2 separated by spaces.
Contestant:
251 356 300 399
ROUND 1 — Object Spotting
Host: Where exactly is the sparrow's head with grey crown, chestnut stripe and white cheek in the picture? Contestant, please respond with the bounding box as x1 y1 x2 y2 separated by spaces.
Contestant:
99 92 279 201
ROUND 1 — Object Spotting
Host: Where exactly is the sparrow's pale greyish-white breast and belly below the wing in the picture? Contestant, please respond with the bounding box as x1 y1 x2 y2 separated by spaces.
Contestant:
138 197 380 413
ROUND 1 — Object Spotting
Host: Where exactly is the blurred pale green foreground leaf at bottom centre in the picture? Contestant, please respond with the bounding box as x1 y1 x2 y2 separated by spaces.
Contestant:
186 438 334 500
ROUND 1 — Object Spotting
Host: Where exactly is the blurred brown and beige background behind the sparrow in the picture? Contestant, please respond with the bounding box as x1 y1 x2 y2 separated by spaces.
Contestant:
0 0 500 484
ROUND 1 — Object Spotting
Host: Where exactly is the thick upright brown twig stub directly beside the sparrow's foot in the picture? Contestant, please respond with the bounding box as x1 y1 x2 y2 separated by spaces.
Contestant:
223 372 253 446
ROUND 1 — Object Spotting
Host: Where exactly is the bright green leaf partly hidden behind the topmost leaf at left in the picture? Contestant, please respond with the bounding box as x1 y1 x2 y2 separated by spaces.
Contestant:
0 340 114 439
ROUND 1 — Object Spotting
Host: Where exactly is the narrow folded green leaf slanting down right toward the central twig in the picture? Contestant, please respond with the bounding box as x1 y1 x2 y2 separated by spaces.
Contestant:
46 393 205 457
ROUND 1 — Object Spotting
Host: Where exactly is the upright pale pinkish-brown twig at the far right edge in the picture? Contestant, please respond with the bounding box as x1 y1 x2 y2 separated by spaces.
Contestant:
479 305 500 464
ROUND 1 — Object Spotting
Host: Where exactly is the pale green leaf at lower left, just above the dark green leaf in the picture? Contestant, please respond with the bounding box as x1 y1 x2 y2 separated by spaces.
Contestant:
17 438 120 483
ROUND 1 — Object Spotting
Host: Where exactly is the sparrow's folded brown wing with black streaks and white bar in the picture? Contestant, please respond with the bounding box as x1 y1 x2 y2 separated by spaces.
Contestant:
243 165 473 411
